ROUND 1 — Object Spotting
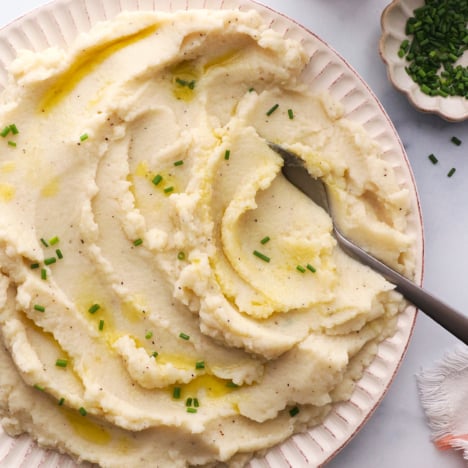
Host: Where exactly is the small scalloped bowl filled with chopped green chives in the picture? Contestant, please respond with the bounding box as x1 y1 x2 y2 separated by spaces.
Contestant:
379 0 468 121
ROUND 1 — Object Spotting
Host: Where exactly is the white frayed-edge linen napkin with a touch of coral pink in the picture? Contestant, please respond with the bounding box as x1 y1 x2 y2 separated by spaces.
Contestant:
417 346 468 460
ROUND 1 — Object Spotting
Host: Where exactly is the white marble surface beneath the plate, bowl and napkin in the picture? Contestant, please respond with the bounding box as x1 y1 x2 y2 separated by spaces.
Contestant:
0 0 468 468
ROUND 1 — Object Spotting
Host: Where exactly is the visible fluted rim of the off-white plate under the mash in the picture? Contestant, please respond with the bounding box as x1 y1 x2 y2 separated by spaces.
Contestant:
0 0 423 468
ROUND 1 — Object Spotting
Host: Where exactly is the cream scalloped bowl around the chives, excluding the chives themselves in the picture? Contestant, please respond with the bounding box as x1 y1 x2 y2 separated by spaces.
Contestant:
379 0 468 122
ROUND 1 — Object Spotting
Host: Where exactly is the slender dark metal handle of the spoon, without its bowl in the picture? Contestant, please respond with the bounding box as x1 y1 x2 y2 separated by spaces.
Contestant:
334 229 468 344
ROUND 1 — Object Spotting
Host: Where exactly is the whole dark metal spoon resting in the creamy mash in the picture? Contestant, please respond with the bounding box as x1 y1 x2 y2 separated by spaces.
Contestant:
269 143 468 344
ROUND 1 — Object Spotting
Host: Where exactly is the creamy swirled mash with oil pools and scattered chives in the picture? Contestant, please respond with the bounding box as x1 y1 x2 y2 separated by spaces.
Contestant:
0 10 414 467
